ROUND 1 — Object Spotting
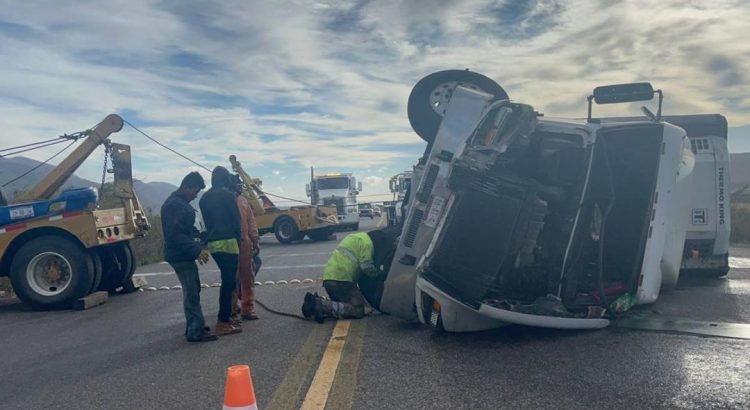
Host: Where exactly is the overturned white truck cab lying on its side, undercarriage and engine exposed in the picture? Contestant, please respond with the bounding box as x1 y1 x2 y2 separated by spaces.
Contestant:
380 70 723 332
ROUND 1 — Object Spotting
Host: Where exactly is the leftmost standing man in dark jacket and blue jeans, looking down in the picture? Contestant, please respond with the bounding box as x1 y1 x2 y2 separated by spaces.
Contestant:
161 172 218 342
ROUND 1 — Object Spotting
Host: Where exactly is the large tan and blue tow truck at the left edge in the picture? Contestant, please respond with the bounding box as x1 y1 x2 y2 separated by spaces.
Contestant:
0 114 149 309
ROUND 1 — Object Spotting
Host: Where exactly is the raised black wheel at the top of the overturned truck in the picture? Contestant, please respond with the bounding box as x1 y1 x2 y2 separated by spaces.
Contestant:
407 70 508 144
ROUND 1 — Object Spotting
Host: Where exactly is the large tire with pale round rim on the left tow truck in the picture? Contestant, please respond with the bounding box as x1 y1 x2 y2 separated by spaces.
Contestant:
10 235 95 310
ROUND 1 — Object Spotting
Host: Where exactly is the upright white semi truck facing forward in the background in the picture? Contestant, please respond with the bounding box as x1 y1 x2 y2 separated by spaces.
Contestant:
305 168 362 231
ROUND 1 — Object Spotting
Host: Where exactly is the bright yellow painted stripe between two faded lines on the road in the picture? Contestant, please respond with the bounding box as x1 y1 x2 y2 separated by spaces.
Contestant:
302 320 351 410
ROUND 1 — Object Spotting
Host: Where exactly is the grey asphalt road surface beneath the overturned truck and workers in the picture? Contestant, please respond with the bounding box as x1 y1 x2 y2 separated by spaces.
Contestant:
0 216 750 409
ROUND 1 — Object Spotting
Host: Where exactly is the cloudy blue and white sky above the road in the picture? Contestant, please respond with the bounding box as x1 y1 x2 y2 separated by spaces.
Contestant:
0 0 750 204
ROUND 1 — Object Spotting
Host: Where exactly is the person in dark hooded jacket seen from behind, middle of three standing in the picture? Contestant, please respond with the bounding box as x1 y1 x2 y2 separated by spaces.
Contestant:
200 167 242 336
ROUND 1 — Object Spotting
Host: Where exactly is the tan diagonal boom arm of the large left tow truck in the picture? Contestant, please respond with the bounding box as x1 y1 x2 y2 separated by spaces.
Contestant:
17 114 123 202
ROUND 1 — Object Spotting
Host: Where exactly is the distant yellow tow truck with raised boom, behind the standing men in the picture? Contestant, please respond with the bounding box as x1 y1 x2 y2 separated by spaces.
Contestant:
229 155 338 244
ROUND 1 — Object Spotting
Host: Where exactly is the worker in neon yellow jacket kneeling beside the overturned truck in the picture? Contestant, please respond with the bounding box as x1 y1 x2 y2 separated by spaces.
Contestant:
302 228 397 323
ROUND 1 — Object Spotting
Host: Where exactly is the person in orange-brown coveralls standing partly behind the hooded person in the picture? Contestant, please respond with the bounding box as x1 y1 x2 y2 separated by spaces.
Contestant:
232 175 260 321
